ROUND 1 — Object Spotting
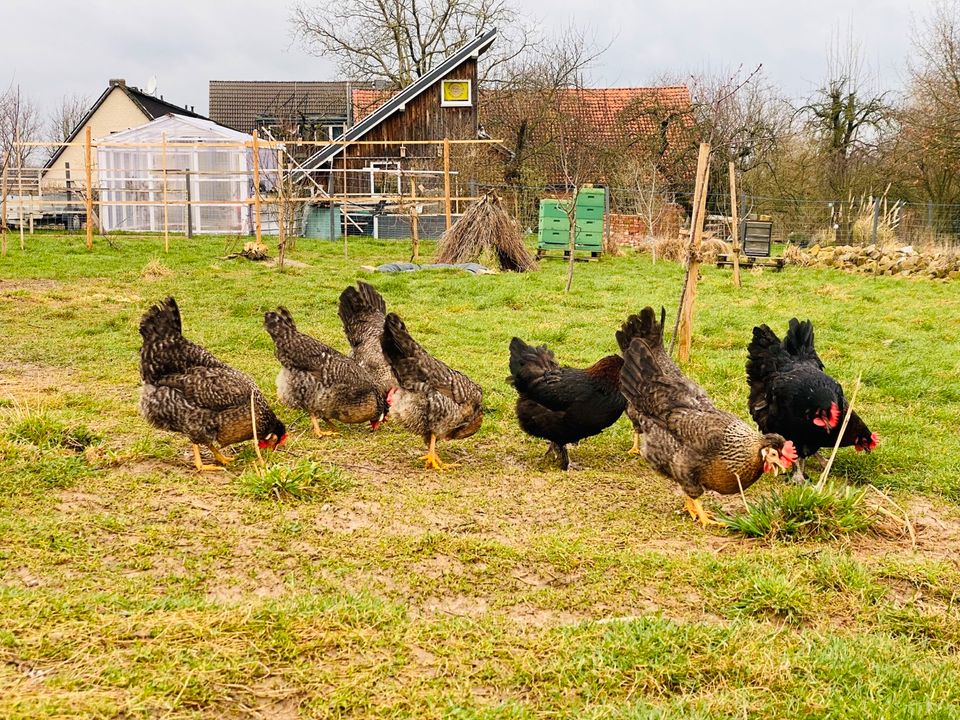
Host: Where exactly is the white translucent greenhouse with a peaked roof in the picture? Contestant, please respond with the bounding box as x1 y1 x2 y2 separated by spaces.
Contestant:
95 114 277 234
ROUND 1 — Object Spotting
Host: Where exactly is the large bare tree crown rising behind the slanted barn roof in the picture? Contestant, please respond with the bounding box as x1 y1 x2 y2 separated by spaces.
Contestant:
290 0 534 88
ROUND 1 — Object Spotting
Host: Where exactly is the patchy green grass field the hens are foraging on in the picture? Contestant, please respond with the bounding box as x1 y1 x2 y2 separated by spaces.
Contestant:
0 235 960 719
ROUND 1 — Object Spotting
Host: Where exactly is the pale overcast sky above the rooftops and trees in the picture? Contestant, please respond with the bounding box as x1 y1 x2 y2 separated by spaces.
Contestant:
0 0 933 122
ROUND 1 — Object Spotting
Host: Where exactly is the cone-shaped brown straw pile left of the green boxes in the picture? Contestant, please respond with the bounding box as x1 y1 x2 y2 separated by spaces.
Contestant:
436 192 537 272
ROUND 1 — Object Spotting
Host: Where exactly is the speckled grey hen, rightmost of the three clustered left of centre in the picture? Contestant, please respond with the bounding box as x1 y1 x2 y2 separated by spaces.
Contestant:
381 313 483 470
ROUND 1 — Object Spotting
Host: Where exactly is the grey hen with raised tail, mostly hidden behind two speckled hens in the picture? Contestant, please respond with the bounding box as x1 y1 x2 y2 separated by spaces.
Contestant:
338 282 397 395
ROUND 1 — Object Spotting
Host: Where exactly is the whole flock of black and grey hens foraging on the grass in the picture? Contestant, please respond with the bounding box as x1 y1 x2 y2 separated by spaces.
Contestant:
140 282 877 525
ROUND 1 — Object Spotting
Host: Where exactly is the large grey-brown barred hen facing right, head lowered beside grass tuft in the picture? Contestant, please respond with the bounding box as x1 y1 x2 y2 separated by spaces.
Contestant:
620 307 796 526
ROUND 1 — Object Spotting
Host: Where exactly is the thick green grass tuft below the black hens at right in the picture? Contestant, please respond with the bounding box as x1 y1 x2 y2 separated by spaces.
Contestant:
721 482 874 541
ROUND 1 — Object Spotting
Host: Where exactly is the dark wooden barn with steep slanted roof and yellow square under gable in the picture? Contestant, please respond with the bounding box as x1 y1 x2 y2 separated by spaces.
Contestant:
301 30 496 211
